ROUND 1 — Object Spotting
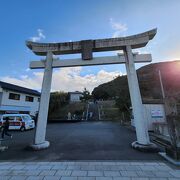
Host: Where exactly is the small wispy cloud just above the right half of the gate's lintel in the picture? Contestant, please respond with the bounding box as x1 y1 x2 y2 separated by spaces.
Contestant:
110 18 128 37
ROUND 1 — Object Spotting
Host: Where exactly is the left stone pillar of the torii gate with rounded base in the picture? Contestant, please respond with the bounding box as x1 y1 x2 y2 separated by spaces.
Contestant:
31 52 53 150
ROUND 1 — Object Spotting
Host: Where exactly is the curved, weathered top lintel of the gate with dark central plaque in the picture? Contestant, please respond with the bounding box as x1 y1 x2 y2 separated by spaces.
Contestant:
26 29 157 60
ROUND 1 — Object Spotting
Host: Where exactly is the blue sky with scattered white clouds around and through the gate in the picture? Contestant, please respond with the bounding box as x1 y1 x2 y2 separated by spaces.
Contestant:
0 0 180 91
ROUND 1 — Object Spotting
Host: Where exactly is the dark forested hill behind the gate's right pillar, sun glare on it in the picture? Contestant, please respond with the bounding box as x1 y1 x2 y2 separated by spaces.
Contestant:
92 61 180 100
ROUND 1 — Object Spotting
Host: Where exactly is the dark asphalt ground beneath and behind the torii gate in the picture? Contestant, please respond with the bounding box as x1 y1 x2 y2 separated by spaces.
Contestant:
0 121 161 161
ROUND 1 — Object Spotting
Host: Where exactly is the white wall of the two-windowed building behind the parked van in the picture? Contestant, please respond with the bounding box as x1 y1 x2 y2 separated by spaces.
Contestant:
1 89 39 115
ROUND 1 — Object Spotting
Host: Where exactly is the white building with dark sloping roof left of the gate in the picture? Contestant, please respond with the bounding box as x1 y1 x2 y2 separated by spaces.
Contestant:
0 81 40 116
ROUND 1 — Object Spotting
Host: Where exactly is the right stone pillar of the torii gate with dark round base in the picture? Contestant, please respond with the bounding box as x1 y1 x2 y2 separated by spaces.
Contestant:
124 46 157 149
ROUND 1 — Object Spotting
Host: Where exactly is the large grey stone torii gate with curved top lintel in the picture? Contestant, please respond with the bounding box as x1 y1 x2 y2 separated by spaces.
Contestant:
26 29 157 150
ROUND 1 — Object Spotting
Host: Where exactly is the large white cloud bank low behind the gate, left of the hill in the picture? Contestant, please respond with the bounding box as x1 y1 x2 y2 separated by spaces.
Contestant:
0 67 122 92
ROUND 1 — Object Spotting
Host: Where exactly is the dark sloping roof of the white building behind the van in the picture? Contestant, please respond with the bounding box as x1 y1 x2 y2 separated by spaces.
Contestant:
0 81 41 96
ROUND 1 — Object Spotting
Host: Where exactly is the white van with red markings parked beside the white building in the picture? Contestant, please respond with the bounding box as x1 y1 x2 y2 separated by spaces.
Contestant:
0 114 35 131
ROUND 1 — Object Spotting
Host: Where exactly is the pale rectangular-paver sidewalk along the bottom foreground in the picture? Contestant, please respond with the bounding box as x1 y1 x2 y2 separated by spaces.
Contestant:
0 161 180 180
